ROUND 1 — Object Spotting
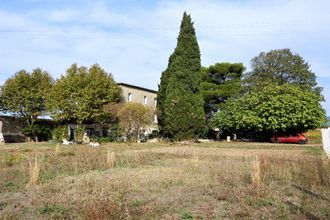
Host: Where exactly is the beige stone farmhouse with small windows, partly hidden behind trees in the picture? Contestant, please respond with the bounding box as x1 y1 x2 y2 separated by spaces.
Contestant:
0 83 157 142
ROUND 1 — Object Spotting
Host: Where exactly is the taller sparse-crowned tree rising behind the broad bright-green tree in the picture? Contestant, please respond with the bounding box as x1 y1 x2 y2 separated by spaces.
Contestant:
245 49 322 95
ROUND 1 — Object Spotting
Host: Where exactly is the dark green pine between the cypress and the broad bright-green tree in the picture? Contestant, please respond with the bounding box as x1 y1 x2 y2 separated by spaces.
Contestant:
201 63 245 119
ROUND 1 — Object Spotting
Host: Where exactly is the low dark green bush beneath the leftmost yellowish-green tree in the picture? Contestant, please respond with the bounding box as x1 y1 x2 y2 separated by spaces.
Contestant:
22 124 51 141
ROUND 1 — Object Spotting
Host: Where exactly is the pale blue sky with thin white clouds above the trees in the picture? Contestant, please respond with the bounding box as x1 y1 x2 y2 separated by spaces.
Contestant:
0 0 330 115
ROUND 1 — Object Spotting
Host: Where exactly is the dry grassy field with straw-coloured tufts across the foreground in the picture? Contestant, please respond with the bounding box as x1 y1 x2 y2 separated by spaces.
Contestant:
0 131 330 219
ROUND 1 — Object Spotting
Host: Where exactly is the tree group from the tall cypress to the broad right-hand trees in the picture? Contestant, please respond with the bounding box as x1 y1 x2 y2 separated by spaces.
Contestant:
158 13 325 140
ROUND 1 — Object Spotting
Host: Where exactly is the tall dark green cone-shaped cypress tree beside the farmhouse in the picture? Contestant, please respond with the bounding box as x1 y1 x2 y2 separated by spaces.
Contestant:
157 13 205 140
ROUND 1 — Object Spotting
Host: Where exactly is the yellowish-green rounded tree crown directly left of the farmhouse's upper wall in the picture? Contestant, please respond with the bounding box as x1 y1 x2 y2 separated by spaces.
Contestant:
47 64 121 125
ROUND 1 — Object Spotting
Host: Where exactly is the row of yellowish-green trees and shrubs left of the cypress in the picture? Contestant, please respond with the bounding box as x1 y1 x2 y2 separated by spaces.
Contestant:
0 64 153 141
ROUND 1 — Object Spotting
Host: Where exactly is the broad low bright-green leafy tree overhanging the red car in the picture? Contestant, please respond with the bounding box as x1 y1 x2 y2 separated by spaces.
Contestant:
213 84 325 137
